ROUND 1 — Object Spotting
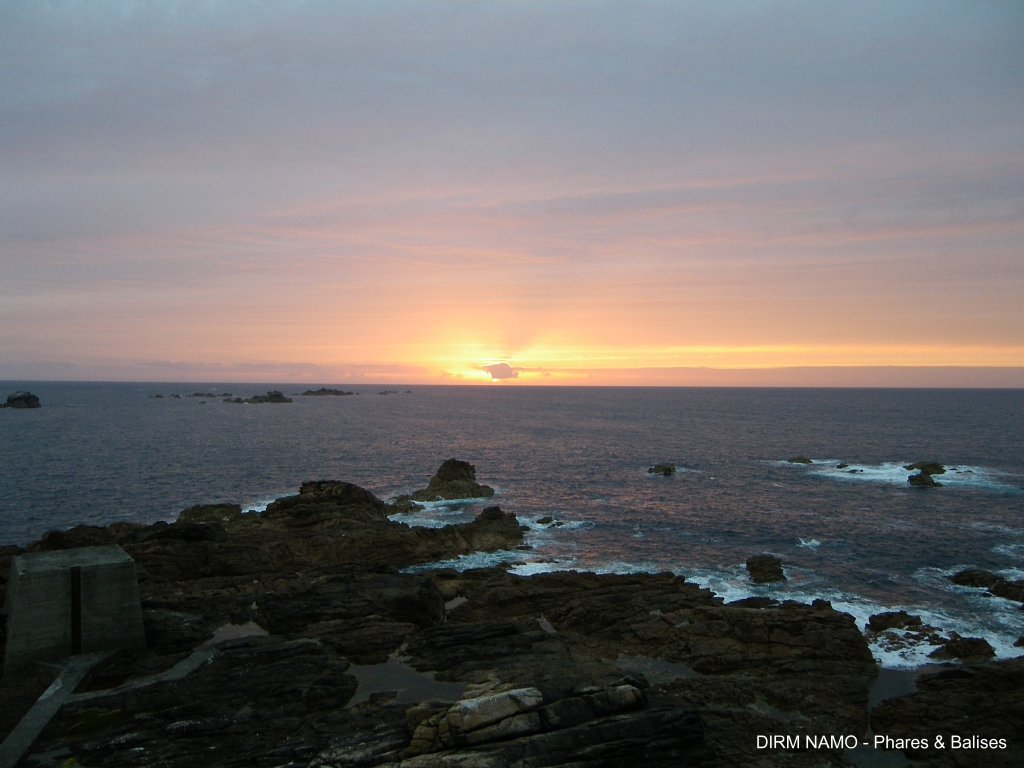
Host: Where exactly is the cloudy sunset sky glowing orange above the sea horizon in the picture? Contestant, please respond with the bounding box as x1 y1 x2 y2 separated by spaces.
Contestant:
0 0 1024 387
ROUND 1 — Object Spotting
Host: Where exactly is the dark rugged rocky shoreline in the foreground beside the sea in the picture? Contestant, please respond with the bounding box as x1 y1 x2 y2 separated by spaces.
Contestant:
0 460 1024 768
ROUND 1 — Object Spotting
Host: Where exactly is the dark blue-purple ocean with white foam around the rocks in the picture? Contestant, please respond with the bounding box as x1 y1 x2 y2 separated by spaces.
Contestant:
0 382 1024 668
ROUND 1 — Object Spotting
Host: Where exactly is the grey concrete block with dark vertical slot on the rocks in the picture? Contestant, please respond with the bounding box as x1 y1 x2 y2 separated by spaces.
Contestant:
4 546 145 674
